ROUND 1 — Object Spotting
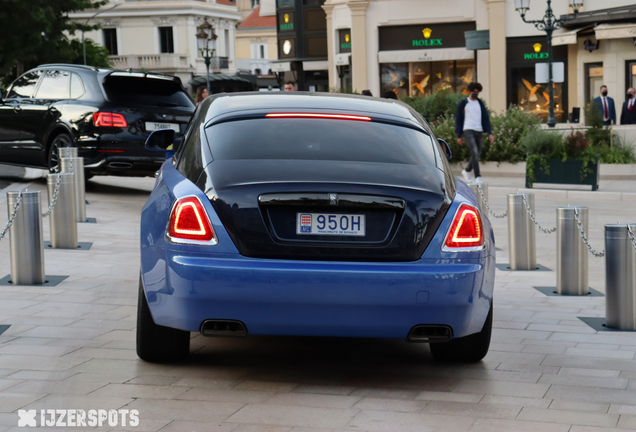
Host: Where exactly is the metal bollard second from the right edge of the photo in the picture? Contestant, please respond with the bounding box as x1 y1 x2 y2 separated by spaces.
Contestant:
557 207 590 295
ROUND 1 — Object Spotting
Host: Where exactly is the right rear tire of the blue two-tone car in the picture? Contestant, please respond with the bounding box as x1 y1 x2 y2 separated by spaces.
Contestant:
429 304 493 363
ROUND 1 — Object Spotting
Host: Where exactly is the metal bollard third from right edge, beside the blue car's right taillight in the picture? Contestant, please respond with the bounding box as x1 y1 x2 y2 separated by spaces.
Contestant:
508 193 537 270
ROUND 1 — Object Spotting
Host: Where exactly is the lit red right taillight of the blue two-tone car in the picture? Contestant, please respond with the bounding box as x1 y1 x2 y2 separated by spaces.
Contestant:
443 204 484 252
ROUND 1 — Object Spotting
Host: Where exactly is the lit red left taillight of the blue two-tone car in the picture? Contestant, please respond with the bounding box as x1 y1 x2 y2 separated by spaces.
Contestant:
168 196 218 245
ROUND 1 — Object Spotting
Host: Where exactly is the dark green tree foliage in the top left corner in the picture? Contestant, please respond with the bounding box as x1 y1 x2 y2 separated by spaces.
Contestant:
0 0 107 83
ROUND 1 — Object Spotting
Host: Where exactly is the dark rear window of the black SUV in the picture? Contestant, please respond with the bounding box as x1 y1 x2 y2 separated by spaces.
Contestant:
104 76 194 107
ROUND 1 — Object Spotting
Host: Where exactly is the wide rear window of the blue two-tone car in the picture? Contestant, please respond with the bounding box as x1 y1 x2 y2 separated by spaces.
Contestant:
208 118 435 166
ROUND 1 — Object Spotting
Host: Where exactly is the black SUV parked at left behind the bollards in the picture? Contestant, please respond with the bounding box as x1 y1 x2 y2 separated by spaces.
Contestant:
0 64 195 178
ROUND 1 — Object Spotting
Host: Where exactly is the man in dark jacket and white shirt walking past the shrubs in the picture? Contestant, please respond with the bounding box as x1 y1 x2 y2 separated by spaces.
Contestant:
455 82 495 183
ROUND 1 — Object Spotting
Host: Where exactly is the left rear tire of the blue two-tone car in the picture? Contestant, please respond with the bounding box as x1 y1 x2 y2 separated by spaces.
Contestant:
137 276 190 363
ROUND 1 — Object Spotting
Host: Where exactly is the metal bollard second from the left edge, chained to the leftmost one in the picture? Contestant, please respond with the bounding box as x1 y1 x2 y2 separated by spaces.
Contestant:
47 174 79 249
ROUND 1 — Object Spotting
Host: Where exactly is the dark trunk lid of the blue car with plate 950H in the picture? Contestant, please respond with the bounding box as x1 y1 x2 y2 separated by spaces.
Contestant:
205 160 450 261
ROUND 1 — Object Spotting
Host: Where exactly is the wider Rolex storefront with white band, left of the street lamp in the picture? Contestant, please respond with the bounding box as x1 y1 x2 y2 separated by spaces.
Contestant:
378 22 477 98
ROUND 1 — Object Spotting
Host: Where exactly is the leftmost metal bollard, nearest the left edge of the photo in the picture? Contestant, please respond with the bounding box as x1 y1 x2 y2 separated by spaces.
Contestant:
7 191 45 285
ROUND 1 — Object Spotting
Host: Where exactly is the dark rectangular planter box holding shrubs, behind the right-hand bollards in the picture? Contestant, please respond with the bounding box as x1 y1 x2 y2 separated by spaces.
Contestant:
526 159 599 191
